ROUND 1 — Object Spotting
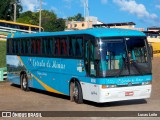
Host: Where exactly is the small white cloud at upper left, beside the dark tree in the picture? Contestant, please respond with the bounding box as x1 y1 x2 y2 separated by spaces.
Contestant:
21 0 39 11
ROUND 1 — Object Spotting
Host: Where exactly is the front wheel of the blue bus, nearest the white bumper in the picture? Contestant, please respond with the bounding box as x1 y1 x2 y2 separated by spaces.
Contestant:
70 81 83 104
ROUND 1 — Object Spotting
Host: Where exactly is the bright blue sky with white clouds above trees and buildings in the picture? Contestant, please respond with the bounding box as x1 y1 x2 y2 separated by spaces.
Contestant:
21 0 160 29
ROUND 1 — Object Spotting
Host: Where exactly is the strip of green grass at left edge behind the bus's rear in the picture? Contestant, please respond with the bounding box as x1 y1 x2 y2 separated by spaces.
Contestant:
0 41 6 68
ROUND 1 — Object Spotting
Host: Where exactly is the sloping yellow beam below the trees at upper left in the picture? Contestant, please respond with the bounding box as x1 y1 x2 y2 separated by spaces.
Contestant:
0 20 43 29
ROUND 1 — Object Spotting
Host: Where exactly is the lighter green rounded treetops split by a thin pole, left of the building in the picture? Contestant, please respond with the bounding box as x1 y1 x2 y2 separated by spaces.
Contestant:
17 10 65 32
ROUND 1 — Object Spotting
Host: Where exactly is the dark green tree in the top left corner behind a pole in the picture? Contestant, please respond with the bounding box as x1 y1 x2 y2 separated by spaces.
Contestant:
0 0 22 20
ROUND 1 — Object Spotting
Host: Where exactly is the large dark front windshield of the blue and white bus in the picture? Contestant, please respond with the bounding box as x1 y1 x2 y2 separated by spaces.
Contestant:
98 37 151 77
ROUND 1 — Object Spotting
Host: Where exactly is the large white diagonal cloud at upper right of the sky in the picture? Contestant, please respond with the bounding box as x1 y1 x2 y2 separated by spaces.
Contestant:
113 0 158 19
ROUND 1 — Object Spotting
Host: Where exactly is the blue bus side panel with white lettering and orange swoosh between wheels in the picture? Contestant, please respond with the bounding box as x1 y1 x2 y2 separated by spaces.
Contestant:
20 56 86 95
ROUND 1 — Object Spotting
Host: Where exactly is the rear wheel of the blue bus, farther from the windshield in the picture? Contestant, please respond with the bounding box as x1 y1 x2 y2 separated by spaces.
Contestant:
21 74 28 91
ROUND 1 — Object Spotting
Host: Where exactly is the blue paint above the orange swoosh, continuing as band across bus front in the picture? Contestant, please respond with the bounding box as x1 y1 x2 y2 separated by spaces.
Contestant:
21 57 152 91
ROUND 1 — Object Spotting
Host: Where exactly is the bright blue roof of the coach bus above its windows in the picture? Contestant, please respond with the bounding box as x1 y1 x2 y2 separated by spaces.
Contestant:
8 28 146 38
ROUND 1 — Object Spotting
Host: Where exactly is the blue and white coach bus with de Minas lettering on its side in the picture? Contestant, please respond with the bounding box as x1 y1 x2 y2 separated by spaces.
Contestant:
7 28 152 103
